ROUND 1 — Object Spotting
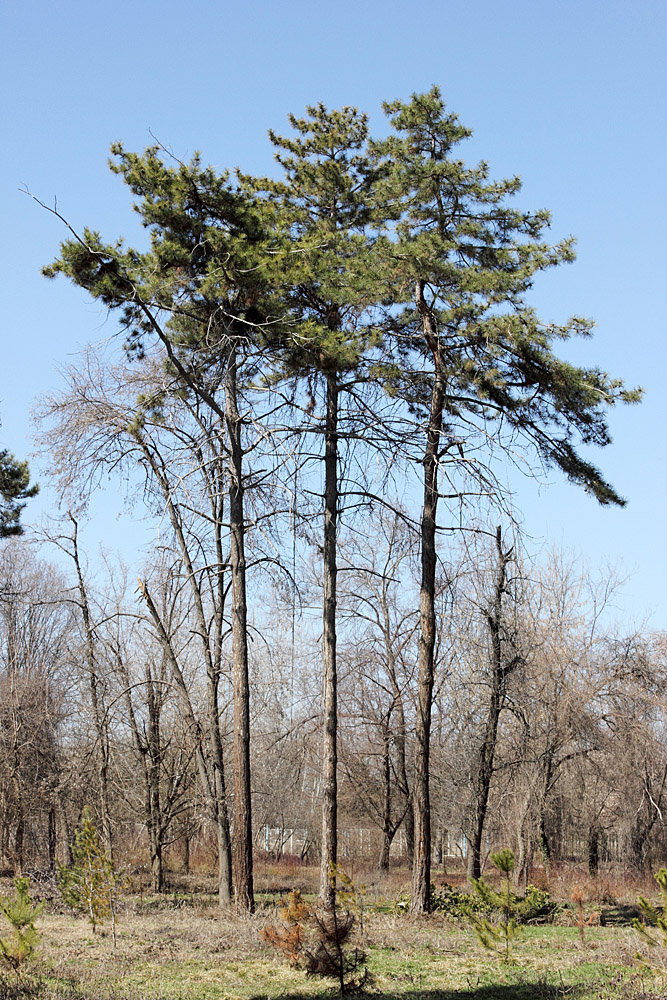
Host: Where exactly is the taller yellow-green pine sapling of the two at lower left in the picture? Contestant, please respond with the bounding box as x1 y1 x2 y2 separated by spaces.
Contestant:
57 806 127 948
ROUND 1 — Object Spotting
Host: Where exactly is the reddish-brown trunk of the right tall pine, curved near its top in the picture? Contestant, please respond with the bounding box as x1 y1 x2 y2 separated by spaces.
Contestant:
410 281 445 913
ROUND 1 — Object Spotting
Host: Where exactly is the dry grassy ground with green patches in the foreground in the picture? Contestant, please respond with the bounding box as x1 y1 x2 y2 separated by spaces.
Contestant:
5 868 667 1000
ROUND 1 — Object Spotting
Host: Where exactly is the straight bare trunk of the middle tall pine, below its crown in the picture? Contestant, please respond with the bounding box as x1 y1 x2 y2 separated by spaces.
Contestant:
320 373 338 910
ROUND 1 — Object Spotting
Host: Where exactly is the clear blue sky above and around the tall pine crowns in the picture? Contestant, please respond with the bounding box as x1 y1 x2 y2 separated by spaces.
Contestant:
0 0 667 627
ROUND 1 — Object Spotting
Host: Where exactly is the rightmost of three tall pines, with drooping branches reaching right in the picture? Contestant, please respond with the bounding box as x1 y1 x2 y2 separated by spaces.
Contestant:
374 88 639 912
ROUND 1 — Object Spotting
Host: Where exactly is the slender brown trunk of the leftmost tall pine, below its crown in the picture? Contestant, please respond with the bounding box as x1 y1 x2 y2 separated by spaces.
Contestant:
225 348 255 913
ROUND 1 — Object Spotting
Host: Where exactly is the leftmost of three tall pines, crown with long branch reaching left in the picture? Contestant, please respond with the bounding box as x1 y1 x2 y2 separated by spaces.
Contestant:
44 150 274 910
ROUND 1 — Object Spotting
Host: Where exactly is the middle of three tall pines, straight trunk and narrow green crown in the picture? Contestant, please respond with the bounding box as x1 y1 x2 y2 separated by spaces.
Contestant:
264 104 386 910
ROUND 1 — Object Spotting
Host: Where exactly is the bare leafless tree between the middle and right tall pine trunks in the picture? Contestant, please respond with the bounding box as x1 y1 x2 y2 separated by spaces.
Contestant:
340 509 417 869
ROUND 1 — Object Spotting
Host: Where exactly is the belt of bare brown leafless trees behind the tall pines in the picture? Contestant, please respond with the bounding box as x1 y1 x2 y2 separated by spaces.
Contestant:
0 532 667 908
